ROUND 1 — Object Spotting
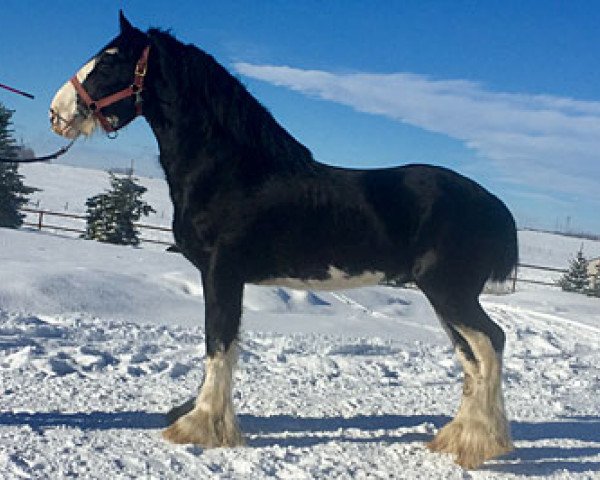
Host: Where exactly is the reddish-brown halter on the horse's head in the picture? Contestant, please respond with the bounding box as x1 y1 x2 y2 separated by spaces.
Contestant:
71 45 150 133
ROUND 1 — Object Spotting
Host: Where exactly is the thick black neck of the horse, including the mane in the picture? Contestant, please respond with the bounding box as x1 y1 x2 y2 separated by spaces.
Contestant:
144 34 316 188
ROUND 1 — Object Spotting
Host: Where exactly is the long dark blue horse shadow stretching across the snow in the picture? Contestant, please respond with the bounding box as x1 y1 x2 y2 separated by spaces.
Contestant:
0 411 600 476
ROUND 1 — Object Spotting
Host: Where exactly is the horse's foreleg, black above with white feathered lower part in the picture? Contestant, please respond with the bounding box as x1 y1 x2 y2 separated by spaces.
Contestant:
163 260 243 448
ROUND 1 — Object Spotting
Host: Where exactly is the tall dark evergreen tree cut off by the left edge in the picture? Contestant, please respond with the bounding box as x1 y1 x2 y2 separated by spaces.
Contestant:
0 103 38 228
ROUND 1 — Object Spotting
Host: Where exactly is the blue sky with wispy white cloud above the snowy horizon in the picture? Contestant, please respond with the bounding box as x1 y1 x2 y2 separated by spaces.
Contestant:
0 0 600 233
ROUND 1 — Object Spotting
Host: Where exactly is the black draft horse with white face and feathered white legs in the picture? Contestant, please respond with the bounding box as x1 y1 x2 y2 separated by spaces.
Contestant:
50 14 517 468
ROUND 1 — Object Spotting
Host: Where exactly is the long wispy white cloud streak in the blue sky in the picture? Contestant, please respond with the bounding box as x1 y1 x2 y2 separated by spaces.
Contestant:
235 63 600 201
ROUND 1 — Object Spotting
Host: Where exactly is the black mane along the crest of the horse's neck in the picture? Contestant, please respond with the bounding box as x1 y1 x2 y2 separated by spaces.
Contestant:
148 29 313 172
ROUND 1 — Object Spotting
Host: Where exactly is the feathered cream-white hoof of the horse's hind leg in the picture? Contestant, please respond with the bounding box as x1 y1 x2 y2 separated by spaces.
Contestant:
427 420 513 470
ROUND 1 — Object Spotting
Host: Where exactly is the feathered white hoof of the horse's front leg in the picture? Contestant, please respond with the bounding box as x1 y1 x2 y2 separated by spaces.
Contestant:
162 411 244 448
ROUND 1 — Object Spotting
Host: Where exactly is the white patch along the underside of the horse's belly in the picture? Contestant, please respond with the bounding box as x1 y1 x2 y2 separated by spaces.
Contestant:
254 266 385 291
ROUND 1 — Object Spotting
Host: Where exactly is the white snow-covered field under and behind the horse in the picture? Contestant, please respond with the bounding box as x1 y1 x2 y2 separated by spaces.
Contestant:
0 165 600 479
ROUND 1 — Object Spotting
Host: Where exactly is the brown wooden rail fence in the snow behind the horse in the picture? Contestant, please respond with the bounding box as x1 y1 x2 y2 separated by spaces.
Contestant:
21 208 567 291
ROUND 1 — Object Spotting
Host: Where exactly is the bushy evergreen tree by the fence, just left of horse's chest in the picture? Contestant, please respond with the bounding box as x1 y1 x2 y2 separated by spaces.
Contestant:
82 173 154 245
